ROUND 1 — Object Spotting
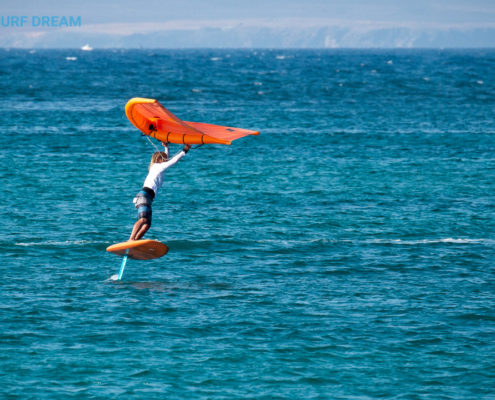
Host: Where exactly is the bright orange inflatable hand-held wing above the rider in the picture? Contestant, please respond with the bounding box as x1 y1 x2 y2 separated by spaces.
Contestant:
125 97 259 145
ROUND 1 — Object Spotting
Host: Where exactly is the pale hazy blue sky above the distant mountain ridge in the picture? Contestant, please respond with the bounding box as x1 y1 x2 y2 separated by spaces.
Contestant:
0 0 495 26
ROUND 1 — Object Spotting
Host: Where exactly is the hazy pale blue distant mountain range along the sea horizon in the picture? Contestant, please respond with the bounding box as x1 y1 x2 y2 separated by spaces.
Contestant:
0 20 495 49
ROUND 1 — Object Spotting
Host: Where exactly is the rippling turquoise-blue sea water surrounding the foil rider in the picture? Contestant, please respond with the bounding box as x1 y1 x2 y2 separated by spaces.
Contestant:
0 50 495 399
